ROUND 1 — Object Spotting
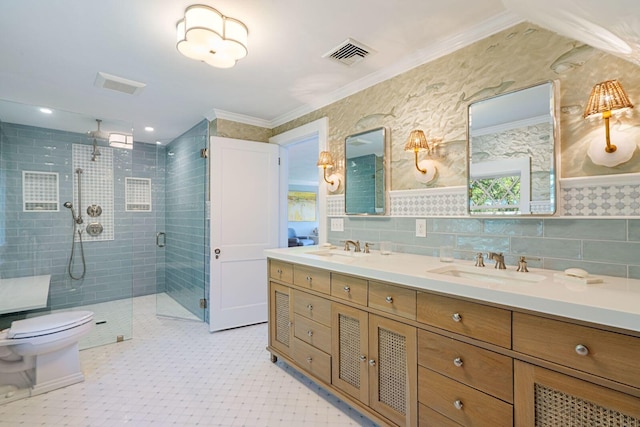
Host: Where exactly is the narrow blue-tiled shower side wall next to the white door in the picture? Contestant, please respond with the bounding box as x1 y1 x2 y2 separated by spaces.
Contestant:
165 121 208 318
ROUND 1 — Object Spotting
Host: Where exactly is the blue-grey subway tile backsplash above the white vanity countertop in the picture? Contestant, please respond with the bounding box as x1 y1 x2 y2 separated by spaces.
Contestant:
327 216 640 279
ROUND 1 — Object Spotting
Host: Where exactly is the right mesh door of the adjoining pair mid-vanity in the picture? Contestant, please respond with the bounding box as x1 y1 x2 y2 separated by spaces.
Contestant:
369 314 418 426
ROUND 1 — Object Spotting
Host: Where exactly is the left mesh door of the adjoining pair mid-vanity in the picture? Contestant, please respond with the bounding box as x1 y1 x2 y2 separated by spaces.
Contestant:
331 303 369 405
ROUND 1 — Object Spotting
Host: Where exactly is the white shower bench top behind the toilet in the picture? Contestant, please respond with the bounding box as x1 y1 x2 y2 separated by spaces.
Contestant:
0 274 51 314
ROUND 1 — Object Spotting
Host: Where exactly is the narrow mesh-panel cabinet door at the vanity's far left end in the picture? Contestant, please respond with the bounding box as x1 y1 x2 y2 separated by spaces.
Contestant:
269 282 293 361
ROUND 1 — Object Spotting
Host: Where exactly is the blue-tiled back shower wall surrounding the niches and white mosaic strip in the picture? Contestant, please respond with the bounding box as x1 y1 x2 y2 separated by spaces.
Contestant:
0 123 170 320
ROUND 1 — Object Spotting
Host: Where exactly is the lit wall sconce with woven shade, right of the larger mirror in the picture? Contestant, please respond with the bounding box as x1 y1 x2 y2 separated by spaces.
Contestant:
582 80 636 167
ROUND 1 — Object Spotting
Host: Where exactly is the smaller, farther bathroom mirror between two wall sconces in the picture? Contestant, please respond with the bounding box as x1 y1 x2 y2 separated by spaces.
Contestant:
344 127 389 215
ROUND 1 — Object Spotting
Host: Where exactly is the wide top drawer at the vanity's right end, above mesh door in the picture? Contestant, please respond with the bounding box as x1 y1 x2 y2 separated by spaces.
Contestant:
513 313 640 388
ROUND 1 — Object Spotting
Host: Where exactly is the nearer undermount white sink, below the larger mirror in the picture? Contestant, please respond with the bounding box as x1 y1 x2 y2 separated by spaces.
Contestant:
428 264 545 285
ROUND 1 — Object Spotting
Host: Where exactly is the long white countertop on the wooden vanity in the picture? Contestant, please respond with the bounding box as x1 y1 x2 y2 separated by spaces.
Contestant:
265 246 640 332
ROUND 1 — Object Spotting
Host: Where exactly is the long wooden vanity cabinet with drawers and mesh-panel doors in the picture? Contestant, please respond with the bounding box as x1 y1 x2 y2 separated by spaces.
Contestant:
269 259 640 427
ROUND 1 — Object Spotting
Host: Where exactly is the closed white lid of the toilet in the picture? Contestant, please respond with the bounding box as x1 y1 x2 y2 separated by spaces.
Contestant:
7 311 93 339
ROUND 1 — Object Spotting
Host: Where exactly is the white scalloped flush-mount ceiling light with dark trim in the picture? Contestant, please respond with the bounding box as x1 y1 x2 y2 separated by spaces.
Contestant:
176 4 249 68
